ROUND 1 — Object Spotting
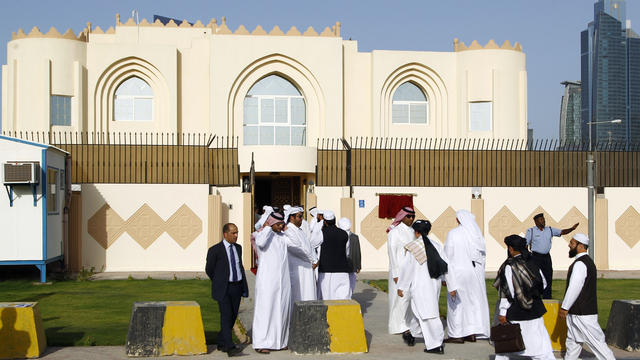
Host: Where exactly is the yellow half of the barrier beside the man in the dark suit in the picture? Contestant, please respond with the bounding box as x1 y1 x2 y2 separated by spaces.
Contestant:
160 301 207 355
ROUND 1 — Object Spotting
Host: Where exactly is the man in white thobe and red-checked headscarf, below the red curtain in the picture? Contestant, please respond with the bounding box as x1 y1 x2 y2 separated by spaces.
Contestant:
387 206 417 344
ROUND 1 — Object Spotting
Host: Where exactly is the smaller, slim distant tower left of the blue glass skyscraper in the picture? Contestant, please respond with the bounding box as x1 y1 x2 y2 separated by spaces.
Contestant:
560 81 582 143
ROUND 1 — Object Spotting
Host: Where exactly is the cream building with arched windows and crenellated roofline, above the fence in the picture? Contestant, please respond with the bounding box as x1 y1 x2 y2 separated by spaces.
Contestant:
2 16 527 173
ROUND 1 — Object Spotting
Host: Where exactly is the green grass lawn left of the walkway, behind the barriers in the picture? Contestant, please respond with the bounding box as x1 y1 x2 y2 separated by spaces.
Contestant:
0 279 220 346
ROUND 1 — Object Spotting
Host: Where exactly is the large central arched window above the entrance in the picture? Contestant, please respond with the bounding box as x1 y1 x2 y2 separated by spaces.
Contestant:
242 75 307 146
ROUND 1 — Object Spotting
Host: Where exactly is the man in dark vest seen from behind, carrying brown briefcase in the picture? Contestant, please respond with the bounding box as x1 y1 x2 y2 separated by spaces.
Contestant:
493 235 555 360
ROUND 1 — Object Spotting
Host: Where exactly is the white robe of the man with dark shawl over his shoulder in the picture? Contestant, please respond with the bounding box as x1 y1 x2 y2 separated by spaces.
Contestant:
397 237 447 349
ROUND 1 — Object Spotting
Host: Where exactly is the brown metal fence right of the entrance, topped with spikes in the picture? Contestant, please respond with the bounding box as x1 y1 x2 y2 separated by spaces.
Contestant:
316 138 640 187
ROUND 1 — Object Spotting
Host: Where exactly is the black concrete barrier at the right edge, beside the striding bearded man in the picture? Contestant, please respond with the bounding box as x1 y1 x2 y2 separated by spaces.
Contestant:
605 300 640 351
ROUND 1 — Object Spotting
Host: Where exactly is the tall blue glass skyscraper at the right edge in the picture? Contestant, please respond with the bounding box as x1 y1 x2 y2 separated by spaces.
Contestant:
580 0 640 146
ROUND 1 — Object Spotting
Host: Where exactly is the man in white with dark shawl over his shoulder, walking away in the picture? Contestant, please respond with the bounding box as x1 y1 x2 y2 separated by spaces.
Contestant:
397 220 447 354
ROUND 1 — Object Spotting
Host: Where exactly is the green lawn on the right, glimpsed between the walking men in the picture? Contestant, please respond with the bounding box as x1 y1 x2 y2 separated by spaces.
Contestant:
368 279 640 329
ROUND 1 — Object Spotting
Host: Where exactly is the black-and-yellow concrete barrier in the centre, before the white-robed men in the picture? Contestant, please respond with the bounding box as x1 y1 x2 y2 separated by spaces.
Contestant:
289 300 367 354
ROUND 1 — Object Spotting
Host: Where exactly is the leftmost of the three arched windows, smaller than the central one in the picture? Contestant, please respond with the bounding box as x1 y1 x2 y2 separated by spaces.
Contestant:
113 76 153 121
